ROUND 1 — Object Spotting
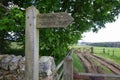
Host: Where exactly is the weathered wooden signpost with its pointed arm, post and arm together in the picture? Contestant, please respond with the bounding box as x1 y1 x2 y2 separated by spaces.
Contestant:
25 6 73 80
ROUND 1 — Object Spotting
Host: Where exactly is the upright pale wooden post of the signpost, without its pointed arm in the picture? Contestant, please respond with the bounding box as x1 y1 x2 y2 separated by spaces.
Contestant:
25 6 39 80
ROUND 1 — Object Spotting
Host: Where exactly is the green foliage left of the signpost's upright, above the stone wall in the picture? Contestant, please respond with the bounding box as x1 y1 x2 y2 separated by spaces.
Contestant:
0 2 25 53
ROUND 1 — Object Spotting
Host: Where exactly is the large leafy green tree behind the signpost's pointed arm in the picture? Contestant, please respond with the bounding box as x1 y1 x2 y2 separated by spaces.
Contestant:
0 0 120 58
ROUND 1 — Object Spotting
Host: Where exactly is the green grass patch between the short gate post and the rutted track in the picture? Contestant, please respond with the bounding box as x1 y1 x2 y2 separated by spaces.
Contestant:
72 54 85 72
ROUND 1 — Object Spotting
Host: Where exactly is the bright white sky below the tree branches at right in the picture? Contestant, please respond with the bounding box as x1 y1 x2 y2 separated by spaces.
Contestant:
80 15 120 42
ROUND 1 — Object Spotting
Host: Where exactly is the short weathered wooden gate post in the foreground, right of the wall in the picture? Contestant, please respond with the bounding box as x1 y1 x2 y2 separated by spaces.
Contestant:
63 56 73 80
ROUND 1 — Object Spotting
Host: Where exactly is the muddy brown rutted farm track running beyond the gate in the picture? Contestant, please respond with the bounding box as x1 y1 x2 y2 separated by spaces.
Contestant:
78 53 120 75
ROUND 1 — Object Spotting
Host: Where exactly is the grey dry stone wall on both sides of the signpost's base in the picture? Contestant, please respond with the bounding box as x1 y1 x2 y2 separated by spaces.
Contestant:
0 55 56 80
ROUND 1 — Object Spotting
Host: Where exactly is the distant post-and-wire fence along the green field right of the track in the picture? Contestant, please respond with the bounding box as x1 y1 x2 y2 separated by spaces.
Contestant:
76 47 120 57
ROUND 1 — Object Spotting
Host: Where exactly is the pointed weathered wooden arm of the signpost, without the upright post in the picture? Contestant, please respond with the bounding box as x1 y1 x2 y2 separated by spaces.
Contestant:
37 12 74 28
